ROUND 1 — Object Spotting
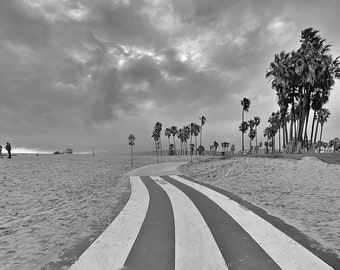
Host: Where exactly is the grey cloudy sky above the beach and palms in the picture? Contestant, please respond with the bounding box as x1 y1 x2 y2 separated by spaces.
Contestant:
0 0 340 153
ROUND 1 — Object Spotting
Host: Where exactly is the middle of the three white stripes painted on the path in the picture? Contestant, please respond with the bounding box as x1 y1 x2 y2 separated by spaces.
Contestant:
152 176 228 270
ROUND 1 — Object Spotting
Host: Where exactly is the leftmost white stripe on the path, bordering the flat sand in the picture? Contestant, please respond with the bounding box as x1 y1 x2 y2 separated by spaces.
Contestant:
70 176 150 270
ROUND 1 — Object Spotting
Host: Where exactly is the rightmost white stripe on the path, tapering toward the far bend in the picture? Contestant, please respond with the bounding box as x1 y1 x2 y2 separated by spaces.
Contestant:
170 175 333 270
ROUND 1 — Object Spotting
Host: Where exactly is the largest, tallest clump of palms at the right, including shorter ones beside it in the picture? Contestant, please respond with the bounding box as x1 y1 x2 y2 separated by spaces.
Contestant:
264 28 340 152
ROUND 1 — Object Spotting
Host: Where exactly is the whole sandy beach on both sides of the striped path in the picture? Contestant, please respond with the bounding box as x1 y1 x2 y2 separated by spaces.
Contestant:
0 155 340 270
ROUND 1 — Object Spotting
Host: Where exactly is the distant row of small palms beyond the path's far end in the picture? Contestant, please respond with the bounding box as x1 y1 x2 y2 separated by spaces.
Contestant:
151 116 207 155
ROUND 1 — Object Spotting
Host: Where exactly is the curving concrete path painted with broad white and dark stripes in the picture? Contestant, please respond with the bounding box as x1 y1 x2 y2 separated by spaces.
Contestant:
70 163 340 270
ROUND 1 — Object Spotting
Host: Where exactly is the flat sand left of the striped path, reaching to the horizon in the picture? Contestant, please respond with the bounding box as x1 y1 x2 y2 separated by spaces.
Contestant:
0 155 194 270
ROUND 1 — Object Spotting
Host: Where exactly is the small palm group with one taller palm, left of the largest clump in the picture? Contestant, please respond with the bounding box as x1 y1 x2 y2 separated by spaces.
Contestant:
239 98 261 152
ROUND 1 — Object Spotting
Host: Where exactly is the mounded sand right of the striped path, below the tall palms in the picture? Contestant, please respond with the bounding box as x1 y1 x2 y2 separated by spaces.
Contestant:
180 157 340 257
